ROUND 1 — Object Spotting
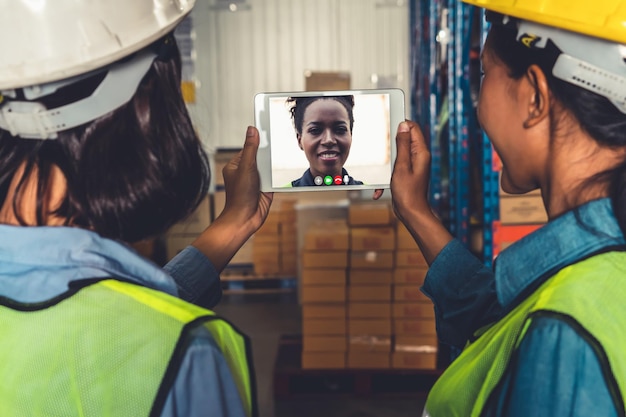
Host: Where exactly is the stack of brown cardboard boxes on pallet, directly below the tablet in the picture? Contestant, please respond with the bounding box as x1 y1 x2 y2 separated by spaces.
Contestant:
301 203 438 369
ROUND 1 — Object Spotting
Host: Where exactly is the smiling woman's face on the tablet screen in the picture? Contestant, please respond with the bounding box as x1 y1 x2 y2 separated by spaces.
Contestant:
297 98 352 177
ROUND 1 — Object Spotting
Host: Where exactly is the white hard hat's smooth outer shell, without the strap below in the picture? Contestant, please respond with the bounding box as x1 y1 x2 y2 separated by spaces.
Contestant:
0 0 195 90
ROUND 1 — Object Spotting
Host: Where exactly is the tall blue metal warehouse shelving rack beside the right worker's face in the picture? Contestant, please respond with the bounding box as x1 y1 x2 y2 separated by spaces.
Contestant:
411 0 498 266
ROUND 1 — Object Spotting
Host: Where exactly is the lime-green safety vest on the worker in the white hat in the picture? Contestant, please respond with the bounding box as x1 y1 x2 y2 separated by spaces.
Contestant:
0 279 257 417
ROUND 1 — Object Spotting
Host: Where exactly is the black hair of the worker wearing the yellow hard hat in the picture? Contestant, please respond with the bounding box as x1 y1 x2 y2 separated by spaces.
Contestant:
485 12 626 234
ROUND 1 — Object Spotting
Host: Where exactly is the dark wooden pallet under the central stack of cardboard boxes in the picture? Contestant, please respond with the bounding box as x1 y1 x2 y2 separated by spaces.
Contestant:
274 335 441 400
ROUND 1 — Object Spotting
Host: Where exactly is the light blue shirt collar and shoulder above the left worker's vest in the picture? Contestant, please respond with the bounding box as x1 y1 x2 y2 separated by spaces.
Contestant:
0 225 177 302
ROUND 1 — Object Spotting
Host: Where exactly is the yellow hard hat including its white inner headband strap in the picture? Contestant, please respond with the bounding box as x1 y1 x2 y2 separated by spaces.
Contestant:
462 0 626 113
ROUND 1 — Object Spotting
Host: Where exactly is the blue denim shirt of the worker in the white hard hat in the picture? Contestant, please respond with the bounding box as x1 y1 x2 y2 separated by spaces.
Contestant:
0 225 245 417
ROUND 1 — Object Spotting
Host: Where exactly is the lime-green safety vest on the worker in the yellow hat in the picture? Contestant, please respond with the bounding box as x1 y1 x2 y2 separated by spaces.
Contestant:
424 252 626 417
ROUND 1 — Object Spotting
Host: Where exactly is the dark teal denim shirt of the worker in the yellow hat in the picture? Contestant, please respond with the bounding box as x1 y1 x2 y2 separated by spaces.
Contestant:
422 199 626 417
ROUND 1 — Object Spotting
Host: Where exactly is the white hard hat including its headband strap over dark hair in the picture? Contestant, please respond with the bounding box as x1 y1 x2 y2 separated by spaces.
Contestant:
0 0 195 139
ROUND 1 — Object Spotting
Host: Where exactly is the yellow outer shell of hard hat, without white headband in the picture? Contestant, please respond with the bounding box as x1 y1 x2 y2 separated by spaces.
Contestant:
462 0 626 44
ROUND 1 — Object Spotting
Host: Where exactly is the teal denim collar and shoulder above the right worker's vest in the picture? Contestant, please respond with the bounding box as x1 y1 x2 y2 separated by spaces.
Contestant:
495 198 625 309
